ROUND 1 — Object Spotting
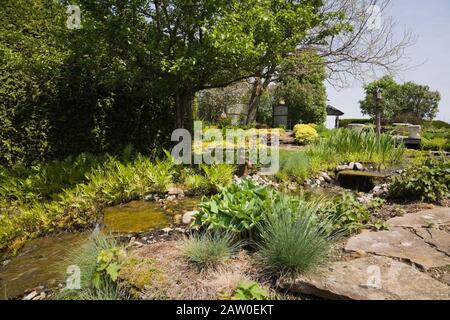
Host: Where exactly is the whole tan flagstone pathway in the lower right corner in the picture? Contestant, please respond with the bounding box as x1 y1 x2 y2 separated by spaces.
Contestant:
280 207 450 300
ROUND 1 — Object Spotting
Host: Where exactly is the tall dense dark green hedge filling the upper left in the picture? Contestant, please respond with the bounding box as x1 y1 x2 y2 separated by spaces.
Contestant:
0 0 174 166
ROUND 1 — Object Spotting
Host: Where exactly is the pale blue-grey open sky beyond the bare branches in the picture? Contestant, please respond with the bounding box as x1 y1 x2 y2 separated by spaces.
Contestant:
327 0 450 126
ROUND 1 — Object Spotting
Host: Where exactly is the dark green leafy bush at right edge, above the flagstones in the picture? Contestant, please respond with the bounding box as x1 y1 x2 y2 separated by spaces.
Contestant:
389 157 450 202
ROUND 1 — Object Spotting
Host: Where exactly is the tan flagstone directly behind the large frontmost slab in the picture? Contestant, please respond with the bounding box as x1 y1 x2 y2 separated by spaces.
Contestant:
345 228 450 270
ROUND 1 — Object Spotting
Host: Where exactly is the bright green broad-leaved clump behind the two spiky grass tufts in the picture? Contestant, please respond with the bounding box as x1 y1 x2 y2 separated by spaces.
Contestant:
194 180 274 239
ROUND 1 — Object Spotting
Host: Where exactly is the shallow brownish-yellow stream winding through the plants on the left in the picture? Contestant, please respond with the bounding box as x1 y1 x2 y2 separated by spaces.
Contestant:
0 198 200 300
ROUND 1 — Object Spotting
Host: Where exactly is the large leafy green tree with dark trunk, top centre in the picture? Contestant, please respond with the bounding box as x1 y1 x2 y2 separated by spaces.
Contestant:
75 0 341 127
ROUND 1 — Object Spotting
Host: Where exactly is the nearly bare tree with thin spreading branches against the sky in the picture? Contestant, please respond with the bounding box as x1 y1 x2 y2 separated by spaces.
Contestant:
247 0 414 123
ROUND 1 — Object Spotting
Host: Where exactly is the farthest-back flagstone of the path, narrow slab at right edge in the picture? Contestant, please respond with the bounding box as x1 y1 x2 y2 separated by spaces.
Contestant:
387 207 450 228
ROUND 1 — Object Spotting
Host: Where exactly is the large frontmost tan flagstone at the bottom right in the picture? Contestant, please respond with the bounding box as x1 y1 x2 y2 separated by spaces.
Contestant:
279 256 450 300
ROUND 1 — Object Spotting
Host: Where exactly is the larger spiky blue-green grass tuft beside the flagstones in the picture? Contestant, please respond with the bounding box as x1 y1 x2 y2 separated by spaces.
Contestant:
259 197 335 274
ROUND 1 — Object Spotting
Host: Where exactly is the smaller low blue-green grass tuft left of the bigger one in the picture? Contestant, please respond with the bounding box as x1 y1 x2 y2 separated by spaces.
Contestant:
182 232 239 268
